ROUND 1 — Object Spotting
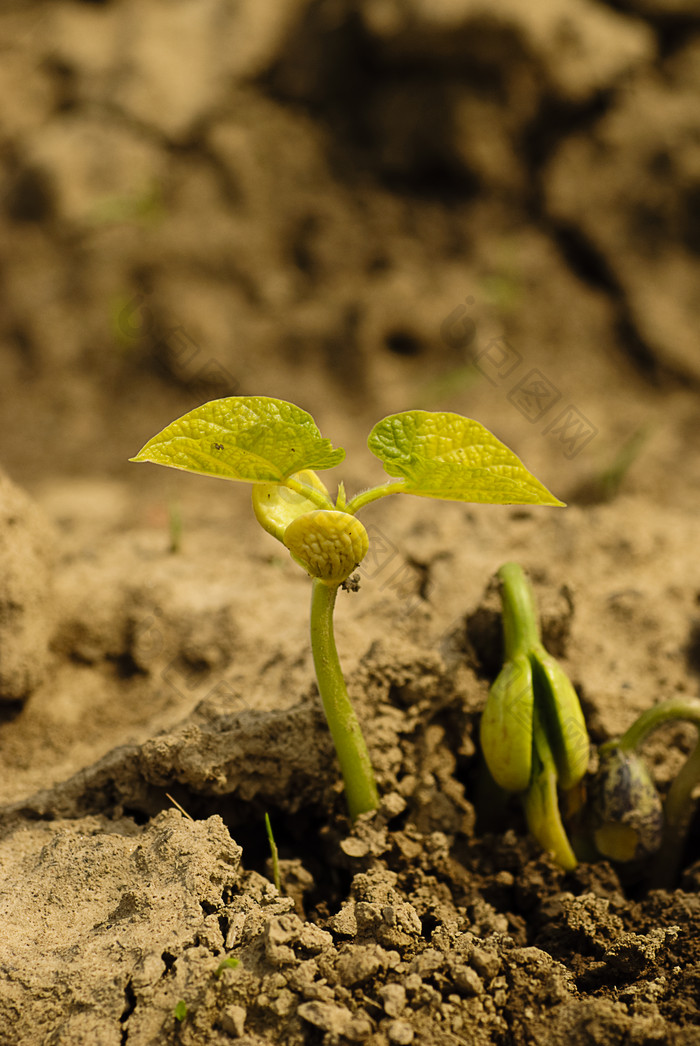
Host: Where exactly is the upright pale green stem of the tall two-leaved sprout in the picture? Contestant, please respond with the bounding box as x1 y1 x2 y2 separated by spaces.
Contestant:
311 578 379 821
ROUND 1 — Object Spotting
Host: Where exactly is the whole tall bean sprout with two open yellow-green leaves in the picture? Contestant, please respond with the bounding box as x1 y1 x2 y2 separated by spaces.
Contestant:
131 396 563 820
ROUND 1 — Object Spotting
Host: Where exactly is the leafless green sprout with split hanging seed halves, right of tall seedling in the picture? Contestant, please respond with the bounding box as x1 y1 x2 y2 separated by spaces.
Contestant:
480 563 588 870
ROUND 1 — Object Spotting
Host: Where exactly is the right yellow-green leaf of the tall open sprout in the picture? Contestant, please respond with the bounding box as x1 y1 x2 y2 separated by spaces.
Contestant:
367 410 564 505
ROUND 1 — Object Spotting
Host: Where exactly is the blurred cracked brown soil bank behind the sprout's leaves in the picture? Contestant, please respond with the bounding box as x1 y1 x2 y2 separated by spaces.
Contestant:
0 0 700 505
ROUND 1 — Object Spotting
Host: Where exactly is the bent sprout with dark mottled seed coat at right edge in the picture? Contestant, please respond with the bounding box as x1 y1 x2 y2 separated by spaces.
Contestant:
590 698 700 887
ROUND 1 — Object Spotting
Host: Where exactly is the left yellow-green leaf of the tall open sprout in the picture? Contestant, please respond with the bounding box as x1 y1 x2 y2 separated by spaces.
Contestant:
130 395 345 483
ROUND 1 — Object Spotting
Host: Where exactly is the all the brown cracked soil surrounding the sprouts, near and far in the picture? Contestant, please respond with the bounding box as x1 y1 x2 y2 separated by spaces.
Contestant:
0 0 700 1046
